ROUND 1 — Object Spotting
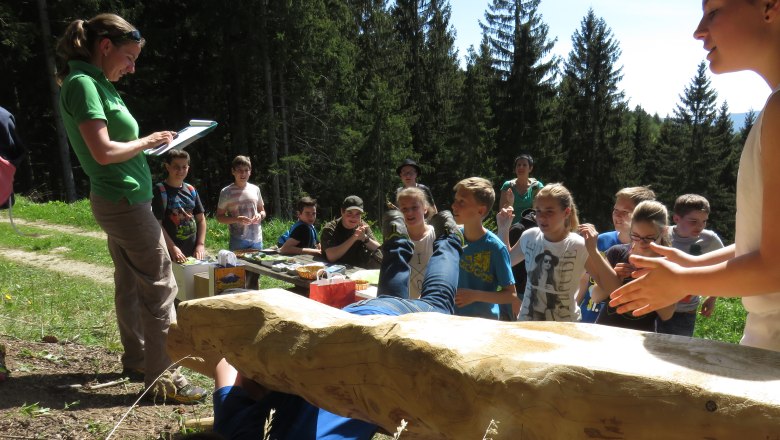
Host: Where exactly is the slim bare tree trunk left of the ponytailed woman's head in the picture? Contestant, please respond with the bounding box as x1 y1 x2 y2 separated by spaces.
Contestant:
38 0 76 202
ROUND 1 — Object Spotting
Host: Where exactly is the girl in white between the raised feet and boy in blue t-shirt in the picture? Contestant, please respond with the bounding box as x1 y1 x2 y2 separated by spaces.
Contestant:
396 187 435 299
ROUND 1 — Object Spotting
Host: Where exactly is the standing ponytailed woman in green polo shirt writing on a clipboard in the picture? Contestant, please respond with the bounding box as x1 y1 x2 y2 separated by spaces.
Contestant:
57 14 205 403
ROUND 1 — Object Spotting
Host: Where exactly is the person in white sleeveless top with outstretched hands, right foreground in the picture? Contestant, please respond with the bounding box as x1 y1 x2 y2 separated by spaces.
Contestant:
610 0 780 351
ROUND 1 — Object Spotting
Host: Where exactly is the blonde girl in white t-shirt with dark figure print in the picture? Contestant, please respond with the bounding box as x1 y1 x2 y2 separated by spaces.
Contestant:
496 183 599 321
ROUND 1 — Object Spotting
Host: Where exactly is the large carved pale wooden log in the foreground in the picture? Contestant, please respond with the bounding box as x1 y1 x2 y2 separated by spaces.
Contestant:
170 289 780 440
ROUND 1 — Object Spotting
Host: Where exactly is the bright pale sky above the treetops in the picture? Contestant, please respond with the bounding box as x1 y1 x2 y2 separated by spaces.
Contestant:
450 0 770 117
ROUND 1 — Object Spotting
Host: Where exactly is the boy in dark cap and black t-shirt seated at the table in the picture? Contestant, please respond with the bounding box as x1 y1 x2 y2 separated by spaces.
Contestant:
320 196 382 269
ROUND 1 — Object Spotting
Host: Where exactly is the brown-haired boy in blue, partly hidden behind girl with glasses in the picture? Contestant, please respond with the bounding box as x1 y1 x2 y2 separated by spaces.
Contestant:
577 186 655 323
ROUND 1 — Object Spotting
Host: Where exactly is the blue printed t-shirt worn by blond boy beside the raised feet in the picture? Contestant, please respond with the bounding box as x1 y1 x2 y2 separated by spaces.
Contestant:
455 231 515 319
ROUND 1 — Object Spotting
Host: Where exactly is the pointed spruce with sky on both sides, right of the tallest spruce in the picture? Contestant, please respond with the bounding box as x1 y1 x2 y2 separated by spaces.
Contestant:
560 9 634 228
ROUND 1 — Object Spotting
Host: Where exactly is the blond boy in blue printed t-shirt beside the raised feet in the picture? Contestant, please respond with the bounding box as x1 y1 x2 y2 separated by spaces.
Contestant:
452 177 520 319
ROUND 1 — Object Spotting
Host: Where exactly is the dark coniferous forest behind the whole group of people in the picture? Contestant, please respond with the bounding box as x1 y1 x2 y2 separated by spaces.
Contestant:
0 0 755 242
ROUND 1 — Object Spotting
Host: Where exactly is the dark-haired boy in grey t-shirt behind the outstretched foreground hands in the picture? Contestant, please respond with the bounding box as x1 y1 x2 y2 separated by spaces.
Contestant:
658 194 723 337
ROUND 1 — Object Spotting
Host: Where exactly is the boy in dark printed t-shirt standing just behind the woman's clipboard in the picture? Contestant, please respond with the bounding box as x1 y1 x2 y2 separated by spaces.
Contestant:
152 150 206 263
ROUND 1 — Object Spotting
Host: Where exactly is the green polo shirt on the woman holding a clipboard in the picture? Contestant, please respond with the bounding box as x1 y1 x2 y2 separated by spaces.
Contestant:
60 61 152 204
